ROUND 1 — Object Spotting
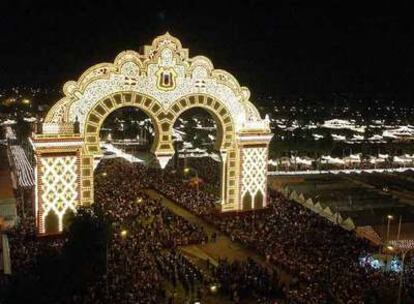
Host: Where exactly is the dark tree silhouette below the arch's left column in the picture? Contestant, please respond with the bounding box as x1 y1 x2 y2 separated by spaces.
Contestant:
0 207 112 303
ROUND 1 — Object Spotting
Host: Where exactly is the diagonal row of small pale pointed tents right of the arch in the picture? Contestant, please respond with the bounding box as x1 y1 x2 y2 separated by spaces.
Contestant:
280 187 355 230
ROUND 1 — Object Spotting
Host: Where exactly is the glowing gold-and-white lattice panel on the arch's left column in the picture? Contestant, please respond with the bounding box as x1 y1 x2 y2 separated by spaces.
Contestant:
40 156 78 231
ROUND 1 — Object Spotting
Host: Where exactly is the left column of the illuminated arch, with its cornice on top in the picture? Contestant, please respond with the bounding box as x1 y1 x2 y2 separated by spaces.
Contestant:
31 132 85 234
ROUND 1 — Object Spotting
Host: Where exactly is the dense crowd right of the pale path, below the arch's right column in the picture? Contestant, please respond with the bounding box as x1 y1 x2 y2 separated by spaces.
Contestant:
210 193 379 303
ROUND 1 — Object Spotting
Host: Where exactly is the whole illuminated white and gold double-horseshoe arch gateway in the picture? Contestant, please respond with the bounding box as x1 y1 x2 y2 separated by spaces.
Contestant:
32 33 271 233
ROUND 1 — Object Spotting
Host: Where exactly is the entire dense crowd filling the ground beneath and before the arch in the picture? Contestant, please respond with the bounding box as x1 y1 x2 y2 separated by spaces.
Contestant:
4 159 414 304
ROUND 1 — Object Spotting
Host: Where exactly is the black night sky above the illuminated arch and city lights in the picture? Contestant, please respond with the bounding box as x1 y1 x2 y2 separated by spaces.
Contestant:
0 0 414 102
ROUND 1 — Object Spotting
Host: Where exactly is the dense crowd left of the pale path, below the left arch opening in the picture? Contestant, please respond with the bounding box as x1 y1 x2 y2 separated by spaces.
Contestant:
75 159 215 303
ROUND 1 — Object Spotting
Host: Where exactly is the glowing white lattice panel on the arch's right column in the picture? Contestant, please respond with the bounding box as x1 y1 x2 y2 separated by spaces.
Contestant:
241 147 267 207
